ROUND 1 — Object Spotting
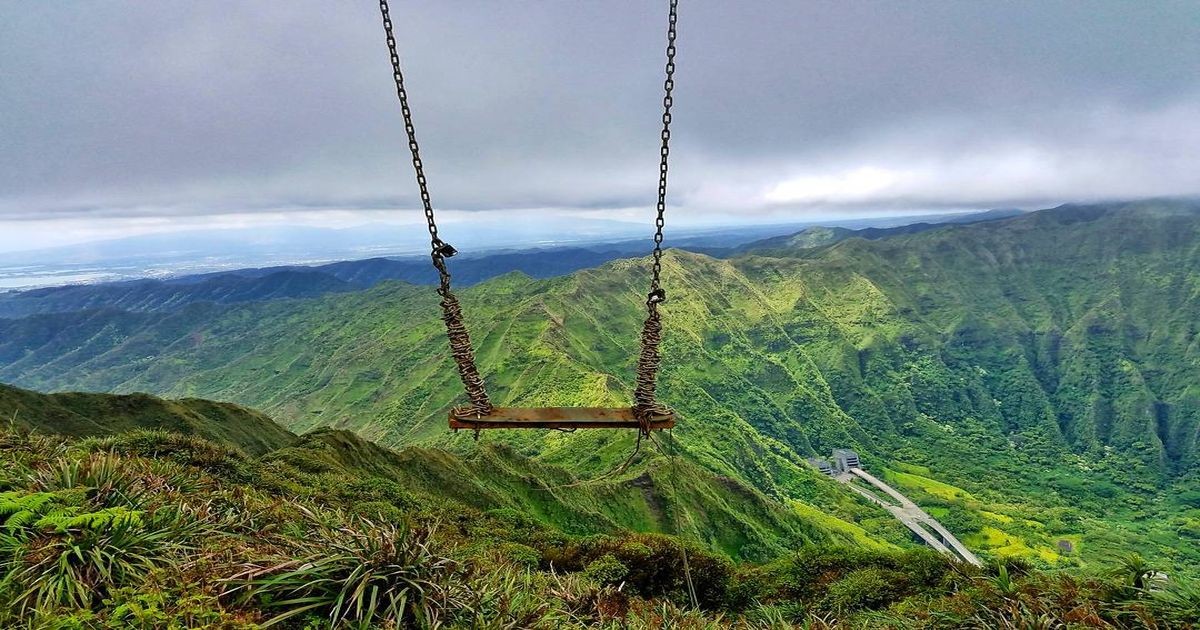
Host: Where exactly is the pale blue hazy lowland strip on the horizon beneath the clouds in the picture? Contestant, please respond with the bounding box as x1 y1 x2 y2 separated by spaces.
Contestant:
0 212 1022 290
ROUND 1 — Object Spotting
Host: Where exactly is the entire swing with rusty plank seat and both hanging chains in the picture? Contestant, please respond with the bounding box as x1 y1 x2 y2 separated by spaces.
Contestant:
379 0 678 436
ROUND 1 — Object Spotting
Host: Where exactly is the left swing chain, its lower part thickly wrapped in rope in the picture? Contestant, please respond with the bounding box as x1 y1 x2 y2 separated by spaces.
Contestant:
379 0 492 416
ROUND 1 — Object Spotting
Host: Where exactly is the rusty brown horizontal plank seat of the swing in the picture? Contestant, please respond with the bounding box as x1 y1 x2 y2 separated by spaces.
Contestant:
450 407 674 431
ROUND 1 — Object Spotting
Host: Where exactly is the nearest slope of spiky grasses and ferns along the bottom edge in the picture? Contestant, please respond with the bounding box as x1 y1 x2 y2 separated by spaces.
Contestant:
0 398 1200 630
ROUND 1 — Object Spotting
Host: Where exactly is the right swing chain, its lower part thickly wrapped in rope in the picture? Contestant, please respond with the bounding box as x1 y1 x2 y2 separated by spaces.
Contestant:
634 0 679 422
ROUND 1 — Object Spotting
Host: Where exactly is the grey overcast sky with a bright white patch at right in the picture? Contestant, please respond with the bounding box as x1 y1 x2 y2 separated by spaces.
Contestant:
0 0 1200 250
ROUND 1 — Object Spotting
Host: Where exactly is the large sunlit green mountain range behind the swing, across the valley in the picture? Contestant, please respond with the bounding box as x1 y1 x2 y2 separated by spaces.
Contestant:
0 202 1200 571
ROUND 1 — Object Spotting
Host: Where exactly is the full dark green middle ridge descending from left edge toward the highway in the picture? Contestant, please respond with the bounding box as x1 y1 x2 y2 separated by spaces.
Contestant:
0 385 883 559
